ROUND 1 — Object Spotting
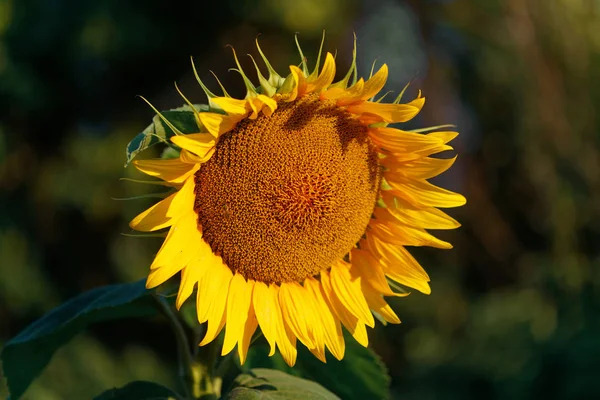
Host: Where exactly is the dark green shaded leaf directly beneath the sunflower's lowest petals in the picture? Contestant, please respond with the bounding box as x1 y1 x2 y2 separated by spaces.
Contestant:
243 334 390 400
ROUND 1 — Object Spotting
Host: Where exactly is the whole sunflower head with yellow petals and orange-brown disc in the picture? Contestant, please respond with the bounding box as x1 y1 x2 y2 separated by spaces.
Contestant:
130 36 465 366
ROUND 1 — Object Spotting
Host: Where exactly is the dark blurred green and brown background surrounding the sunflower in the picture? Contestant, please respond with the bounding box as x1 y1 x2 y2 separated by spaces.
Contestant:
0 0 600 399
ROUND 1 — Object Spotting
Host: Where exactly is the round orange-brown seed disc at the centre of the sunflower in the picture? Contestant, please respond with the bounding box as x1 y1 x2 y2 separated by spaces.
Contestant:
195 95 381 283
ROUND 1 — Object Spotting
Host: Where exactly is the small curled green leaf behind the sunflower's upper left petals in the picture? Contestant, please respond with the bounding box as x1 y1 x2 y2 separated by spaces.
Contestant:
125 104 211 166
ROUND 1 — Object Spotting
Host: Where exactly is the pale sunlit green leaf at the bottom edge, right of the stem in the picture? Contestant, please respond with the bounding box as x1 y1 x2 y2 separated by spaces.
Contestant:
223 368 339 400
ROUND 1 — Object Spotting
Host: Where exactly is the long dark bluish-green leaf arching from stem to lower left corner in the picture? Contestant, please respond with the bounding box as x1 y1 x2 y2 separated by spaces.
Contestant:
0 280 157 399
